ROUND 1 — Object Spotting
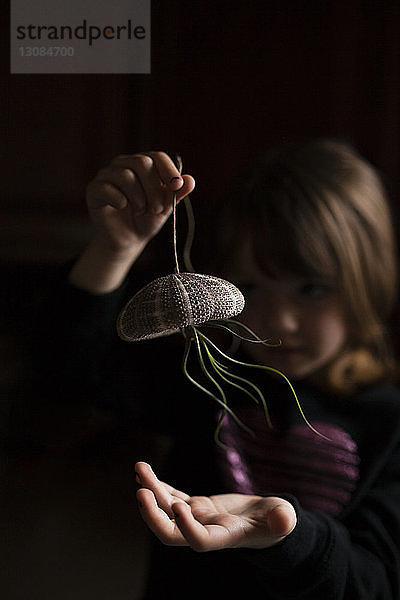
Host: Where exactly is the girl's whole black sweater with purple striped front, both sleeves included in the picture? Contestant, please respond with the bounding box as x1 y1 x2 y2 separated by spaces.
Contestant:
37 283 400 600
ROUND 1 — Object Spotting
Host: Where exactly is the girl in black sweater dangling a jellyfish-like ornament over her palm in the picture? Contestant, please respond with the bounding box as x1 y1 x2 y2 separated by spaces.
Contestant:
53 140 400 600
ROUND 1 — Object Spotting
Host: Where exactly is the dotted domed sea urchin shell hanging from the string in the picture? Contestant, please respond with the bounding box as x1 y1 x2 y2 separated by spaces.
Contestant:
117 273 244 342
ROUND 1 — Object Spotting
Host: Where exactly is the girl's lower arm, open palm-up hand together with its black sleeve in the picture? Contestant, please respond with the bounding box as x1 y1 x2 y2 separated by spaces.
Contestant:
136 448 400 600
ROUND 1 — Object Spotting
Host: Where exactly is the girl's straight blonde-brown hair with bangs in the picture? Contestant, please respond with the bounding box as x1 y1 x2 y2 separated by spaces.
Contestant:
208 140 397 395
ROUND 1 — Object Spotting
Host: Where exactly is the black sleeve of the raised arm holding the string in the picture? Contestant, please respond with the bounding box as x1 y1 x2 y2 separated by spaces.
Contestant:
32 265 185 433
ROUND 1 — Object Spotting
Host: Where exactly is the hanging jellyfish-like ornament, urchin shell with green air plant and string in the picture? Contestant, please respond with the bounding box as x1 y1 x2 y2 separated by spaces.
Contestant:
117 157 322 446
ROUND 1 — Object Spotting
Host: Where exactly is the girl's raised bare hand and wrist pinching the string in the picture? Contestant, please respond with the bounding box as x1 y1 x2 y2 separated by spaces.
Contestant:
69 152 194 294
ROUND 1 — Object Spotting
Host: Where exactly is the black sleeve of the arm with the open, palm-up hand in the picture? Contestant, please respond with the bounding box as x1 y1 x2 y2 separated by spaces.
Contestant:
243 436 400 600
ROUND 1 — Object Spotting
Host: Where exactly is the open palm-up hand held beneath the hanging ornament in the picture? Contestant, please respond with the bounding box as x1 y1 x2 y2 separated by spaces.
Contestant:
135 462 296 552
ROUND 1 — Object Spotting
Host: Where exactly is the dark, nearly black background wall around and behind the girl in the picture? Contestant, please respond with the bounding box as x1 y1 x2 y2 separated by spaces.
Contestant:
0 0 400 600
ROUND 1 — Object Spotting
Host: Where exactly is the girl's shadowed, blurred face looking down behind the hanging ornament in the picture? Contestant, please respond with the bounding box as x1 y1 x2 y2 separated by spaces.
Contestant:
227 241 349 379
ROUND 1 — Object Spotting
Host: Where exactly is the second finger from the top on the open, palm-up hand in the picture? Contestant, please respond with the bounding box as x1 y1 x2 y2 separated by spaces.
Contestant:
136 488 188 546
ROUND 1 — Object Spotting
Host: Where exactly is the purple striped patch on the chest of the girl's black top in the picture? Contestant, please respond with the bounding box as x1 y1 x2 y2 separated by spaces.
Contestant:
218 407 359 516
